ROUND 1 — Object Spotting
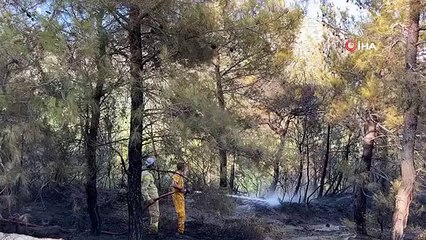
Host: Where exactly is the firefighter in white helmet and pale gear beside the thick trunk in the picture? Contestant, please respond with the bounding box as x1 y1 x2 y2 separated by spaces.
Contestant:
142 157 160 234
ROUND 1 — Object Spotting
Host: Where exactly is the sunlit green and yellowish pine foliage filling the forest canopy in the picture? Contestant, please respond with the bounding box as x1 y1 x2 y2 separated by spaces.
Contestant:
0 0 426 232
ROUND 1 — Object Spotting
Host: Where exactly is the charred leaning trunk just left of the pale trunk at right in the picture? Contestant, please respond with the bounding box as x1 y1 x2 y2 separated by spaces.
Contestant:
354 120 376 235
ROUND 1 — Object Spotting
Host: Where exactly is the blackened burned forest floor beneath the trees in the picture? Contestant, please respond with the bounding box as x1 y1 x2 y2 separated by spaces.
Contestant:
2 185 424 240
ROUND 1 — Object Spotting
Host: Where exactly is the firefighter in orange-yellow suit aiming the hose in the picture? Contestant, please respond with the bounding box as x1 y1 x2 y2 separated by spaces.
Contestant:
172 162 186 235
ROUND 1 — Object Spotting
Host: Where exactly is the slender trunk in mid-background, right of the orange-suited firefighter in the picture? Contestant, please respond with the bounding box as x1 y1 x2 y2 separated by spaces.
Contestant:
213 49 228 187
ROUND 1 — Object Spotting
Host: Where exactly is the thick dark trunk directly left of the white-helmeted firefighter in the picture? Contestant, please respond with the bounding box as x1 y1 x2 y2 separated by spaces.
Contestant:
128 5 144 240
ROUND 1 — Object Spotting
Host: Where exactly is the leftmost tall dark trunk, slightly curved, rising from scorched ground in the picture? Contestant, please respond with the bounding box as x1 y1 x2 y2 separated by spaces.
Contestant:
86 11 107 234
